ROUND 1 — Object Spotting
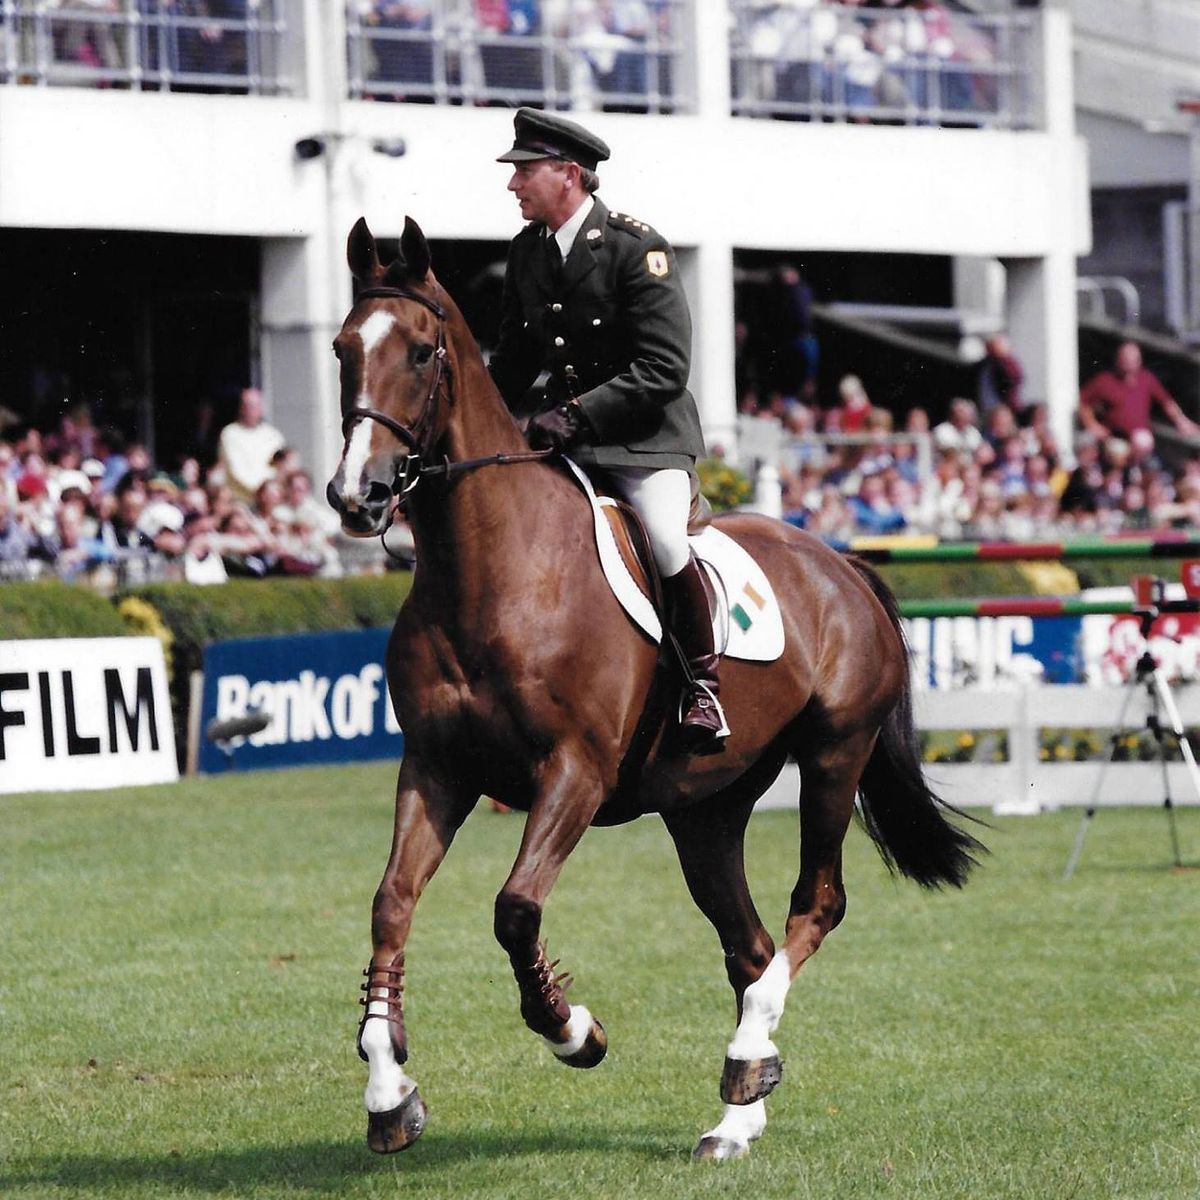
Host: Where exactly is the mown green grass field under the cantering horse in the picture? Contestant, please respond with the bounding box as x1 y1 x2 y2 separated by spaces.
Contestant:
0 767 1200 1200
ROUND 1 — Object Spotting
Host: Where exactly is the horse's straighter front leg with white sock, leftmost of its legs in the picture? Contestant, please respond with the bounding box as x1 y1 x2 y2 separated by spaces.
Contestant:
358 754 475 1154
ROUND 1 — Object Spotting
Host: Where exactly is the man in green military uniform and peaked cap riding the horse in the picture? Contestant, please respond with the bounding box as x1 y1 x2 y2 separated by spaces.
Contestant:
488 108 728 754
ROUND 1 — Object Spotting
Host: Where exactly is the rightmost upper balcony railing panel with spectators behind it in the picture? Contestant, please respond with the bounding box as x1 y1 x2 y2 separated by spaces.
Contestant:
728 0 1039 130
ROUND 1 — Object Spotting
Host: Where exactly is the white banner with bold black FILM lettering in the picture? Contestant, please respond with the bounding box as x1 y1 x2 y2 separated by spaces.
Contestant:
0 637 179 793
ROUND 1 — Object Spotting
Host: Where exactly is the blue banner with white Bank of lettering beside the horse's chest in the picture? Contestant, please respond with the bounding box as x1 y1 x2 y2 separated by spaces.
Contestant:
197 629 404 773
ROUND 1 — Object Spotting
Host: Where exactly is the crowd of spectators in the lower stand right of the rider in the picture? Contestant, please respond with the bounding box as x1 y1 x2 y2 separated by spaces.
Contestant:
742 338 1200 541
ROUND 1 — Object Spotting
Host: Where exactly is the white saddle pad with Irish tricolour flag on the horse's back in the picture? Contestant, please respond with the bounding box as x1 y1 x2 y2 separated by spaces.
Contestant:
566 458 784 662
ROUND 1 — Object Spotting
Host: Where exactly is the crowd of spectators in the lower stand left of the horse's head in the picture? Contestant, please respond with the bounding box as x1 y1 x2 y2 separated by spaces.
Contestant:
0 388 382 583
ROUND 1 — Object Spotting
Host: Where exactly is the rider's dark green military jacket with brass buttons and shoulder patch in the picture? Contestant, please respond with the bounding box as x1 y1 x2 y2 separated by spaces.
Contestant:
488 200 704 469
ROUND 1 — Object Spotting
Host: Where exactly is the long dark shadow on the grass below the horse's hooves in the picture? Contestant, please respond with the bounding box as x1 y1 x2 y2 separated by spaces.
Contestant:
5 1130 679 1195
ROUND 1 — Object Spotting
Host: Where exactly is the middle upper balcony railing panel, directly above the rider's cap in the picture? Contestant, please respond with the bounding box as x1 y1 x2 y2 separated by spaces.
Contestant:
346 0 695 113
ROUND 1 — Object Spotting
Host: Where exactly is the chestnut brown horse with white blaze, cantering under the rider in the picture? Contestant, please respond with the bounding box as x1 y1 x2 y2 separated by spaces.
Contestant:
326 217 982 1160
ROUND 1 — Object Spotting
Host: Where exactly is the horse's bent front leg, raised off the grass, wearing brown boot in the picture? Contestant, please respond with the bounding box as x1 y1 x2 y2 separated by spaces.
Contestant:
494 751 608 1067
